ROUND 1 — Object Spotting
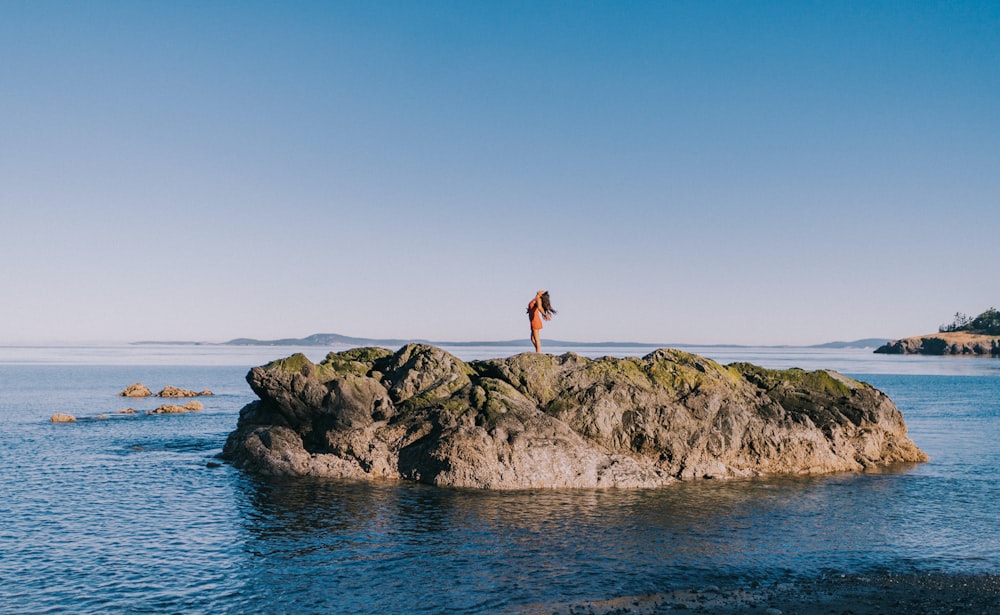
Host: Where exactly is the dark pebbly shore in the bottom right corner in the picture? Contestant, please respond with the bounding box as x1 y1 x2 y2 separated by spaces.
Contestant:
521 573 1000 615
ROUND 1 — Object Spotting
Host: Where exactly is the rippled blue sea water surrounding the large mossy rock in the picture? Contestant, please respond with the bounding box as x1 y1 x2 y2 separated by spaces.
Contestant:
0 346 1000 613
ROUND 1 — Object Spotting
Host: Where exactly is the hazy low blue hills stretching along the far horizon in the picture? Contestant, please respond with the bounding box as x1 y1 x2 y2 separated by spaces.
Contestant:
133 333 892 348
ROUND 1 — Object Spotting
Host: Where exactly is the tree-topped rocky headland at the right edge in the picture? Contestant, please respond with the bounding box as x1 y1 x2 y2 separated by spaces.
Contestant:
875 308 1000 357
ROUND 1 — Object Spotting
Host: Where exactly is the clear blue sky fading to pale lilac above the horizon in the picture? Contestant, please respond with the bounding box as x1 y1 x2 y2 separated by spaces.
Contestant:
0 0 1000 345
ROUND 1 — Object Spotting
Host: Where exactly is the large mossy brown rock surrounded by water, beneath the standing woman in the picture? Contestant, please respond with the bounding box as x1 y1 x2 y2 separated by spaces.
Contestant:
223 344 927 489
